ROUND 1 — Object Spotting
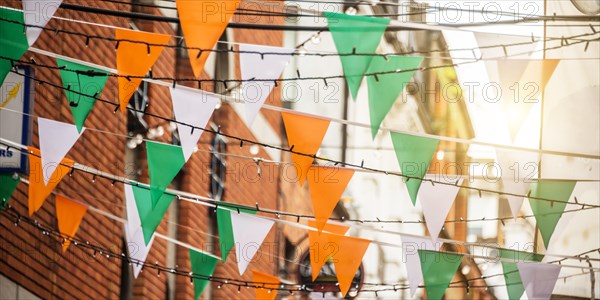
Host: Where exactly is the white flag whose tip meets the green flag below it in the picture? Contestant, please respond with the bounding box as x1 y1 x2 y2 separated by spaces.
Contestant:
171 88 220 161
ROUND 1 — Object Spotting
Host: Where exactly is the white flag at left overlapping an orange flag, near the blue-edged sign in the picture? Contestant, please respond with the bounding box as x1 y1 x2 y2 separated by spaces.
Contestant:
38 118 85 185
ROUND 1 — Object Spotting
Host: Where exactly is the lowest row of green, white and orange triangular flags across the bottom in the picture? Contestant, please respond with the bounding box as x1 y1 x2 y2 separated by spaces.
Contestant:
0 171 561 299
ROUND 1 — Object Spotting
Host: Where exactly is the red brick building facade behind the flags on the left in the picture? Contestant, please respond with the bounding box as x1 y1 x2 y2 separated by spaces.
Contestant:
0 1 312 299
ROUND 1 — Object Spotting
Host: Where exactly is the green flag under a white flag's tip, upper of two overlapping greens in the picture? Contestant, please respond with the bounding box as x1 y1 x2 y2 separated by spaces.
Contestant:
146 142 185 207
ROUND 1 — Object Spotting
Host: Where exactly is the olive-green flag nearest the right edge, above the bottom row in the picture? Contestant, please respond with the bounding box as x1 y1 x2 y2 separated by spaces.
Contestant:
529 180 577 248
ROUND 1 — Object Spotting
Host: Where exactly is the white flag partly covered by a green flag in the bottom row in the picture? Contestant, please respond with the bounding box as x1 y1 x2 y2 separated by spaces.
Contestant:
400 235 442 297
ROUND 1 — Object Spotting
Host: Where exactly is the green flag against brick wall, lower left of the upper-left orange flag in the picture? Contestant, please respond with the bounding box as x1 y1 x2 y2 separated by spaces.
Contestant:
56 58 108 132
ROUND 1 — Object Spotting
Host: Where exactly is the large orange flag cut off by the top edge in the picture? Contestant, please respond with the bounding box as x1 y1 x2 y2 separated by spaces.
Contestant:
176 0 240 78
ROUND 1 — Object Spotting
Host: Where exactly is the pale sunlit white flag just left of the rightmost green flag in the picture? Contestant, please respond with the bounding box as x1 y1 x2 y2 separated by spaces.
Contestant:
496 149 539 218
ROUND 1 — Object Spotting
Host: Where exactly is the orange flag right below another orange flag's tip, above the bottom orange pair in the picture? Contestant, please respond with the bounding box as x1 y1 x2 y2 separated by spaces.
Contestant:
306 166 354 231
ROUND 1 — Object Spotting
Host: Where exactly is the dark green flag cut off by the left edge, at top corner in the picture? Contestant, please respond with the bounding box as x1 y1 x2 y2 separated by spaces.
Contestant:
0 8 29 85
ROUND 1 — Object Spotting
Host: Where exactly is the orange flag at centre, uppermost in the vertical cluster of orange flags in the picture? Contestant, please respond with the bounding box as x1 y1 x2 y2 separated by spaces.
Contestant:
281 113 330 186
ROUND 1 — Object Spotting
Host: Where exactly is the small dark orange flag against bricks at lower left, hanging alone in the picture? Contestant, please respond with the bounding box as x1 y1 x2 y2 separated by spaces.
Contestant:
55 195 87 252
